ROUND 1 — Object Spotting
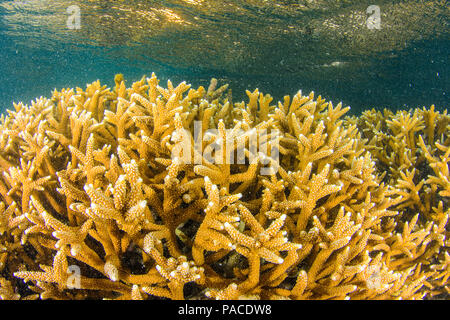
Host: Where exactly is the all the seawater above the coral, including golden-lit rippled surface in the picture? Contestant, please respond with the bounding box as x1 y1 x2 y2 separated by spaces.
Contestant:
0 0 450 113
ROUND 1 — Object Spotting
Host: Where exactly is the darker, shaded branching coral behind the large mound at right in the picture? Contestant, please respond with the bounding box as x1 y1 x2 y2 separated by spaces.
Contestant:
352 105 450 294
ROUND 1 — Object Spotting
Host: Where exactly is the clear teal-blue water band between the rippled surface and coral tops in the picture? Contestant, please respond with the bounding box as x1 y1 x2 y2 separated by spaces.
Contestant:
0 0 450 112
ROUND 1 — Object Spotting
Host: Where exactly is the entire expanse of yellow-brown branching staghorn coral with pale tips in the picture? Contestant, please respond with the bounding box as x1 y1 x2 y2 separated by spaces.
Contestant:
0 74 450 299
